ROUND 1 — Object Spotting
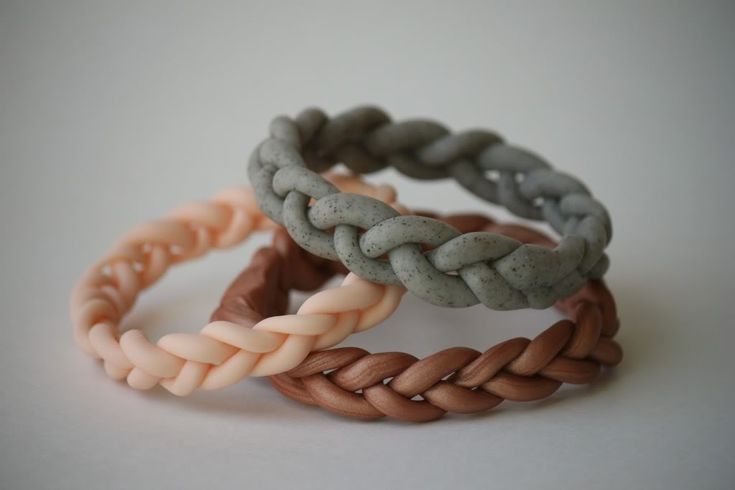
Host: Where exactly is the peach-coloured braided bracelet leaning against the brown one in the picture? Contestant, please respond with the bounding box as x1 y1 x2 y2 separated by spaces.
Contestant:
71 174 406 396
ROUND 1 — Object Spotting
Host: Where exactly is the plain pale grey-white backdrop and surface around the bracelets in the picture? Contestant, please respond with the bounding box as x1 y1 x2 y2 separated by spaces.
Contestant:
0 1 735 490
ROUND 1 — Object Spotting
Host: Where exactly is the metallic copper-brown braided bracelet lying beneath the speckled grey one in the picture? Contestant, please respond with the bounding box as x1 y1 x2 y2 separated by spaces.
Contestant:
212 211 622 422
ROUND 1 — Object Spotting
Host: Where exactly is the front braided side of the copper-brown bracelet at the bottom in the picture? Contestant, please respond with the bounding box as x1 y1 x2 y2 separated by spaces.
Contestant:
270 281 622 422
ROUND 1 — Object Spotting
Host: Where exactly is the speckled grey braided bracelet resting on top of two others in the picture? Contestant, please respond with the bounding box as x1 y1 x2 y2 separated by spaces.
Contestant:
248 107 612 310
